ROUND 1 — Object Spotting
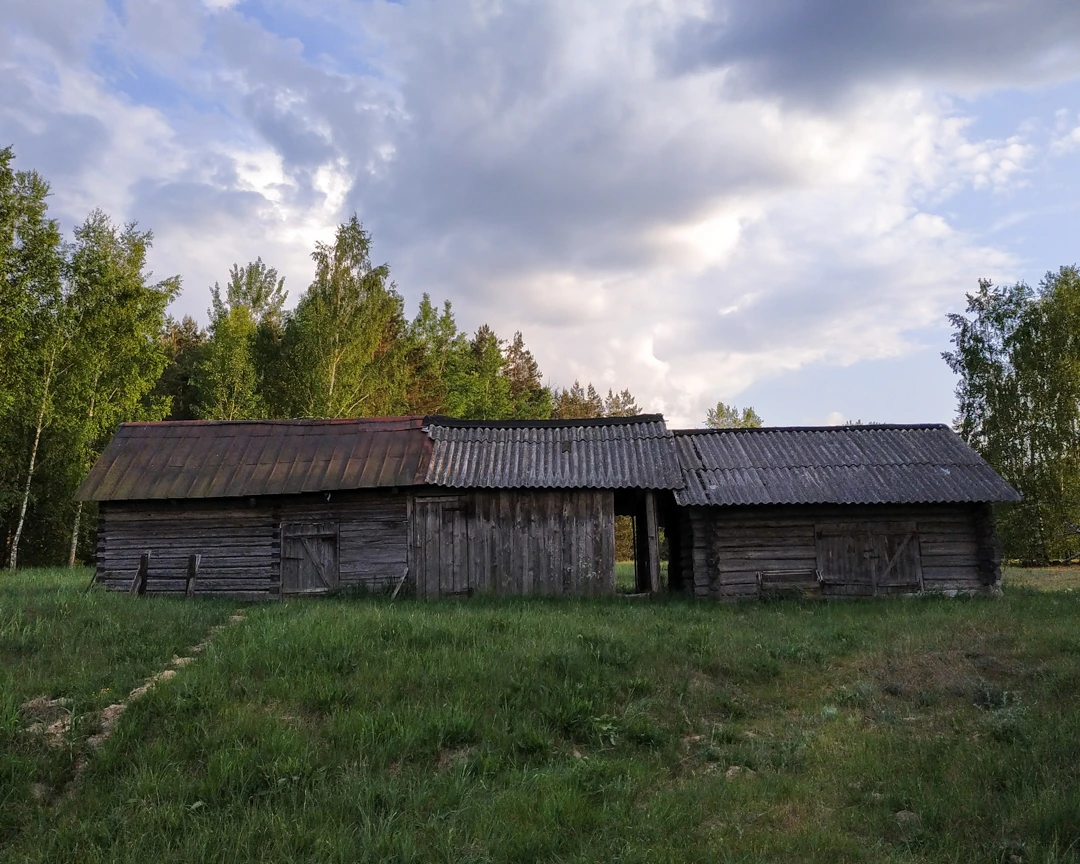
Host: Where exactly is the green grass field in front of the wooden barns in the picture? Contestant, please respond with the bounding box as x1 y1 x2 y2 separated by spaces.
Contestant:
0 570 1080 864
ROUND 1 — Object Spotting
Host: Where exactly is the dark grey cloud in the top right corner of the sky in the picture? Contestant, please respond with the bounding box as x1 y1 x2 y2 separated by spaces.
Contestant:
667 0 1080 102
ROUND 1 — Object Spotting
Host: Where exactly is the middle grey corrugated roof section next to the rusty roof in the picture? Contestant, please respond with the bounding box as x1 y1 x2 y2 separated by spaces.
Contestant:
424 414 683 489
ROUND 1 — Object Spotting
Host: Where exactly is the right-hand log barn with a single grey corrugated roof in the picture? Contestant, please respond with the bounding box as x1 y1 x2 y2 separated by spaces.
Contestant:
672 426 1020 598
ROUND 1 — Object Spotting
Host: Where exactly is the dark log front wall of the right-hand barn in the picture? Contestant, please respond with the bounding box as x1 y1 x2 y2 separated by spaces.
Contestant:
680 504 1001 598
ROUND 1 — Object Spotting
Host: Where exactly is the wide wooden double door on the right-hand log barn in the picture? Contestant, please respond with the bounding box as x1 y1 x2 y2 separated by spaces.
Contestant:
815 522 922 594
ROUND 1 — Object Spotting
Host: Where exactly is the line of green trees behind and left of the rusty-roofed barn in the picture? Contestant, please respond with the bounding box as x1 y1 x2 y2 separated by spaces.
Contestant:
0 148 660 567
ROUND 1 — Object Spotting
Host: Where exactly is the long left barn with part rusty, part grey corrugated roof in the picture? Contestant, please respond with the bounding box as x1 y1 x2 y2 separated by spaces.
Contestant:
78 415 681 598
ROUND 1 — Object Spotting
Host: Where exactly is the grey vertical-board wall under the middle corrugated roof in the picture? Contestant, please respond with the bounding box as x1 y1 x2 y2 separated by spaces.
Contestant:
409 489 615 597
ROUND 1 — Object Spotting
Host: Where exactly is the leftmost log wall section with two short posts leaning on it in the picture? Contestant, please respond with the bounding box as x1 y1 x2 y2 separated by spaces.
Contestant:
96 501 279 599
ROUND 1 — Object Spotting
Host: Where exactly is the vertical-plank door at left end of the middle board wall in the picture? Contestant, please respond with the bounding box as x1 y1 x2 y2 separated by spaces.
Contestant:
413 496 472 597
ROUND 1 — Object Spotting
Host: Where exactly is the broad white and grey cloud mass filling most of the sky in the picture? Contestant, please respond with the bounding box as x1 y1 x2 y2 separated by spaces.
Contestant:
0 0 1067 422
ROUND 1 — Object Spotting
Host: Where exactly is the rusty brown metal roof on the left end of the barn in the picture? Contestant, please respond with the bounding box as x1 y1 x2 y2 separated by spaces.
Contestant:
76 417 431 501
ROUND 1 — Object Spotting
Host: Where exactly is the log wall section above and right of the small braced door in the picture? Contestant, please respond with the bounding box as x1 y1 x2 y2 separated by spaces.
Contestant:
279 491 408 592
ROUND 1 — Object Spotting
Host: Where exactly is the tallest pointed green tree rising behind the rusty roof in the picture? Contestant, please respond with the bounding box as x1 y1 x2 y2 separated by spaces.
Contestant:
272 215 407 417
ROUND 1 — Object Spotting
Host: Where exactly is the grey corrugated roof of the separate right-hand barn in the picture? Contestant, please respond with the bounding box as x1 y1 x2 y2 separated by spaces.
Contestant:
675 424 1021 504
